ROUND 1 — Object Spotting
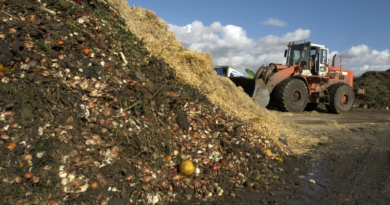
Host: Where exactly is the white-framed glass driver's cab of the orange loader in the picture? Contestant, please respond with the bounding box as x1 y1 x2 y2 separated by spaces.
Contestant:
285 40 328 76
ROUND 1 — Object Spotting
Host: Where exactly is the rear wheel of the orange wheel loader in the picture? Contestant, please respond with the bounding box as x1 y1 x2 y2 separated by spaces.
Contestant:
325 83 355 114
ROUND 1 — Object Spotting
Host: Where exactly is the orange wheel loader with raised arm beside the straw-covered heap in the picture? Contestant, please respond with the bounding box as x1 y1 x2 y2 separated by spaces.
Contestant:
230 40 364 114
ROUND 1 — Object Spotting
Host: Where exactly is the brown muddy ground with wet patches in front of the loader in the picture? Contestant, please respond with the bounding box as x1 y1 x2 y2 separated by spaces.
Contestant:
198 107 390 205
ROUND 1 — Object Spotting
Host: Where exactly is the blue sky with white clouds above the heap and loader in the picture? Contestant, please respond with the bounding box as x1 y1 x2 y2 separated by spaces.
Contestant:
127 0 390 76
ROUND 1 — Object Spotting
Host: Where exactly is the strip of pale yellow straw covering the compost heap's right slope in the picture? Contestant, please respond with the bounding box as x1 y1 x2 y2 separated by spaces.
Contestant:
102 0 290 147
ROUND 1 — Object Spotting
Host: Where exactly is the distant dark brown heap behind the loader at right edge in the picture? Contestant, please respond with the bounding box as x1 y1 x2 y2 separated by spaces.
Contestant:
354 69 390 109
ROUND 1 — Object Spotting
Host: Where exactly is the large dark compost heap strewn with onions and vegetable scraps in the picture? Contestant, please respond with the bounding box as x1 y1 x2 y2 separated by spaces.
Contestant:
0 0 291 204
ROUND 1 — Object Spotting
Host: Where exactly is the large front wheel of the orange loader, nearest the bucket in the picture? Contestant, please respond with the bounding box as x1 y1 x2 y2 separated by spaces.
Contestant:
274 78 309 112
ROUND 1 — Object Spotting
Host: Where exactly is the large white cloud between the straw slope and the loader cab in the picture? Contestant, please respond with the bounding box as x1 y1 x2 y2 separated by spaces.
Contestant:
169 21 310 73
